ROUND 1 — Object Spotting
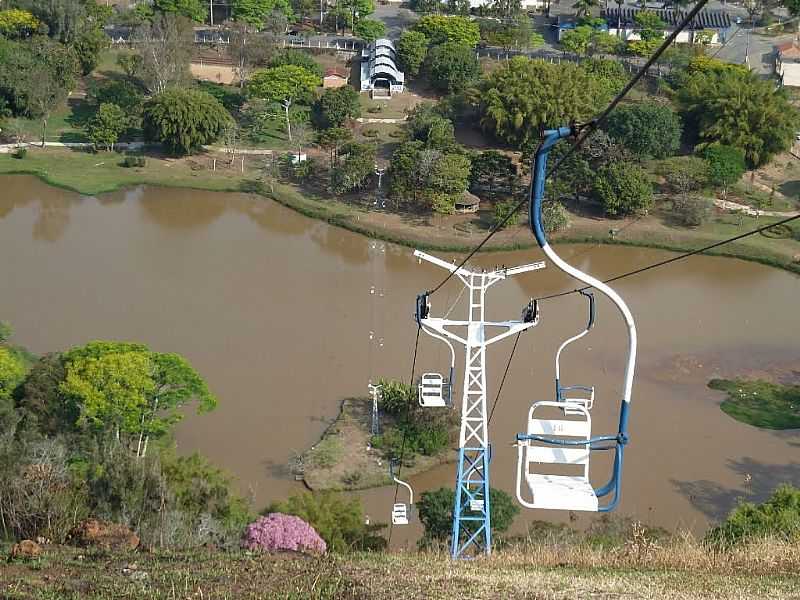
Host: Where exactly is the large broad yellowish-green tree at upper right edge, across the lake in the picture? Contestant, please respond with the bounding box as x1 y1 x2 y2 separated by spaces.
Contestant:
677 69 800 167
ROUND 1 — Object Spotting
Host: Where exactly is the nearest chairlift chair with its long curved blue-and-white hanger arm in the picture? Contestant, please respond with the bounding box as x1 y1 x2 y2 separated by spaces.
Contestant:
516 127 636 512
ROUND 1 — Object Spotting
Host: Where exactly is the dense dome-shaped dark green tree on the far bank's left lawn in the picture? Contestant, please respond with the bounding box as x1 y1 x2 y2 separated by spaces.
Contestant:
143 88 231 154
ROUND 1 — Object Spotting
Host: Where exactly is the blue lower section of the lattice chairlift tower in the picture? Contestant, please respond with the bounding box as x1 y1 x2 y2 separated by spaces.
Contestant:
450 448 492 558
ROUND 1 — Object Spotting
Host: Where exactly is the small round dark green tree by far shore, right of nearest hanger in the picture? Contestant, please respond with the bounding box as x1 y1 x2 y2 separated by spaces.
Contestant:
594 162 653 217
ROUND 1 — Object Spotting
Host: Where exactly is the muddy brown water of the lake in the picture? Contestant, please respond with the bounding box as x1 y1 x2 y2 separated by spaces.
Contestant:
0 176 800 544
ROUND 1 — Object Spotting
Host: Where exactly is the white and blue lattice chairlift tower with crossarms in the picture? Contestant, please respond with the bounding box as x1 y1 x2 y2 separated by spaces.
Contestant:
414 250 545 558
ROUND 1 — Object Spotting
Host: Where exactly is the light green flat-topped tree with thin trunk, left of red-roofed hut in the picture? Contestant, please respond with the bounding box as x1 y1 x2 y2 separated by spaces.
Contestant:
248 65 320 142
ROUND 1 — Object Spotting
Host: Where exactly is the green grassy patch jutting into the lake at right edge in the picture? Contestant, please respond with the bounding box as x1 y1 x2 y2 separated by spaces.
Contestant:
708 379 800 429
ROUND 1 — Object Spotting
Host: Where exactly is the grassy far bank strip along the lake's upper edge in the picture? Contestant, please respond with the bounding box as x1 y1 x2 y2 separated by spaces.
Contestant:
0 150 800 274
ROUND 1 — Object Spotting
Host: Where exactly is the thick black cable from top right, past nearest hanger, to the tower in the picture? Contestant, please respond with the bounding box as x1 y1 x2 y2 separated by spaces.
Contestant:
428 0 708 295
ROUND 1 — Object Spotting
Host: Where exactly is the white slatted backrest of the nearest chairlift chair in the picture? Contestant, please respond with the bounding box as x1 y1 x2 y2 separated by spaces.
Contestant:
525 401 592 478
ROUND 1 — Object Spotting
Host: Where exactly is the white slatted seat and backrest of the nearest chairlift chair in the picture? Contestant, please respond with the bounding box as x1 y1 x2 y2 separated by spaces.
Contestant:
517 402 598 512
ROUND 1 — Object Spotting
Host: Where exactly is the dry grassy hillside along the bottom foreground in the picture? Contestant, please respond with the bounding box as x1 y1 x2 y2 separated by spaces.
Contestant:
0 538 800 600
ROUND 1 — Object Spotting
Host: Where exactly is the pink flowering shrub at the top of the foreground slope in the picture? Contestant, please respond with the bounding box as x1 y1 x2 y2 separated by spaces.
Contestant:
242 513 327 553
